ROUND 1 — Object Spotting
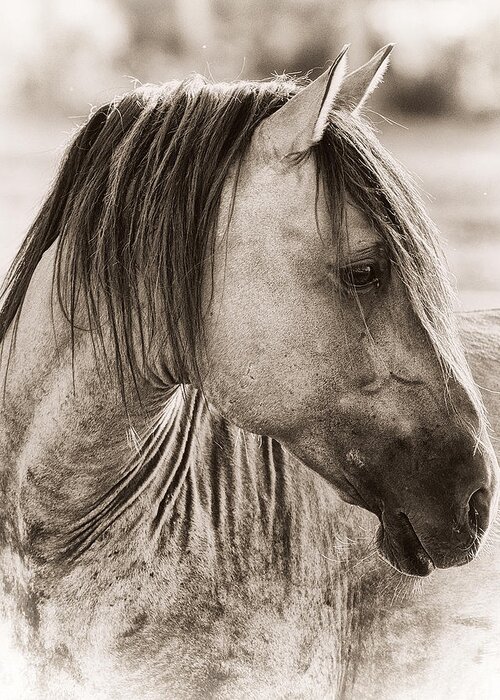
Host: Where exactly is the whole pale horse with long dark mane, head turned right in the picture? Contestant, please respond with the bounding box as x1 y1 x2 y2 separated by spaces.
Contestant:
0 45 500 700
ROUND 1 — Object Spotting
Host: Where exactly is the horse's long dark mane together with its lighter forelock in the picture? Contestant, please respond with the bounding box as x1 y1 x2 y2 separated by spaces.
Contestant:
0 76 485 438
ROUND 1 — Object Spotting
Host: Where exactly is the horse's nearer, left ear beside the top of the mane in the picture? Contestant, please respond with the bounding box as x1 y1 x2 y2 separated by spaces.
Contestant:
256 44 349 158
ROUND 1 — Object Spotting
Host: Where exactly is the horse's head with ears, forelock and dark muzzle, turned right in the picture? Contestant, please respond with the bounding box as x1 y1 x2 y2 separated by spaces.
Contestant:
201 46 497 576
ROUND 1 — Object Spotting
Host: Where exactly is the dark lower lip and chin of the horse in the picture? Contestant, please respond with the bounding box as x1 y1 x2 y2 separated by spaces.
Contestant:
377 513 435 577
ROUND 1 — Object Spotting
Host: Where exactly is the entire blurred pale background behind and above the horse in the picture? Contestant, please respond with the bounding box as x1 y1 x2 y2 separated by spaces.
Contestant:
0 0 500 309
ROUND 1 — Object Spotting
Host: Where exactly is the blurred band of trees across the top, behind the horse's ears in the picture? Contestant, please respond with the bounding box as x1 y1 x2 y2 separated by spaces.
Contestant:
0 0 500 115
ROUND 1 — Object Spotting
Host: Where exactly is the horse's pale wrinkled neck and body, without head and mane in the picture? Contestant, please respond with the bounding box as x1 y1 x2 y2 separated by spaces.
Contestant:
0 243 500 700
